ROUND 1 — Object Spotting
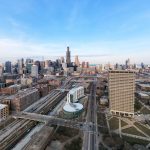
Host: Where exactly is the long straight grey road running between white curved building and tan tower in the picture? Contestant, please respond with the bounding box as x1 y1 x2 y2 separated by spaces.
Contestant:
82 80 98 150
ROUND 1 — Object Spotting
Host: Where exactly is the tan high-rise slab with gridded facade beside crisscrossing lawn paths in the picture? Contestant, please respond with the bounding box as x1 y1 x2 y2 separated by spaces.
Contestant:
109 71 135 116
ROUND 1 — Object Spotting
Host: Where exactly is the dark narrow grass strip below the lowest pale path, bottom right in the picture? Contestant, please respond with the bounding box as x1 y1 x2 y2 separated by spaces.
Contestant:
122 135 149 146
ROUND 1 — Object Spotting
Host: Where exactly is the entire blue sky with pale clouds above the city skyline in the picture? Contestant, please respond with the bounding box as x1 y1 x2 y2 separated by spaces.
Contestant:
0 0 150 64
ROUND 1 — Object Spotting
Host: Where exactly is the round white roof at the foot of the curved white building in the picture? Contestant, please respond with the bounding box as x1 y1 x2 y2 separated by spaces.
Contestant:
63 103 83 112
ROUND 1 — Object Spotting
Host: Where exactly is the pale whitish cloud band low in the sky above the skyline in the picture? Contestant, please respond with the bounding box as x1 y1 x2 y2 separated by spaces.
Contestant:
0 39 150 63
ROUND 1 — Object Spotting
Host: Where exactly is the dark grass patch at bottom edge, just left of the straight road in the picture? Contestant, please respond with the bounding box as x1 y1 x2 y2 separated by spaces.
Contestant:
64 137 82 150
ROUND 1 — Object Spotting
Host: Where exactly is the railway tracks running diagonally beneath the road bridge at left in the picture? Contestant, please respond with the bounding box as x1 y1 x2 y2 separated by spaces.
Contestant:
0 83 74 150
